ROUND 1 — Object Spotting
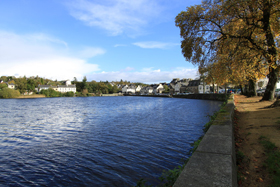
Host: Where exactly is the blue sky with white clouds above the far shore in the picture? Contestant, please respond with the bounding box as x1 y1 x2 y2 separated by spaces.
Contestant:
0 0 201 83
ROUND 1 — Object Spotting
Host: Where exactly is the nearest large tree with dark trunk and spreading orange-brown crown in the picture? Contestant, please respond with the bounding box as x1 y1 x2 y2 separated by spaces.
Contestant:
176 0 280 100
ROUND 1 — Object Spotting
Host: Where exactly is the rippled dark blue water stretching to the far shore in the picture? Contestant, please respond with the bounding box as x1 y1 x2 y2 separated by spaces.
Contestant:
0 97 221 186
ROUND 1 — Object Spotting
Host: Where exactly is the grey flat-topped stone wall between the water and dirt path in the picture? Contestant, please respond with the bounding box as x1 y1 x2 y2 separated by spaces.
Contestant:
173 101 237 187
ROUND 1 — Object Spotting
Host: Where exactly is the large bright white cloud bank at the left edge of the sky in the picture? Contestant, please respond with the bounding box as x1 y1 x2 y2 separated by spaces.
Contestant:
0 31 104 80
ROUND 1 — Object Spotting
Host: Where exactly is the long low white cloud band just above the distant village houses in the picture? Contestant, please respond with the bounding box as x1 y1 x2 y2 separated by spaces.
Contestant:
87 67 197 83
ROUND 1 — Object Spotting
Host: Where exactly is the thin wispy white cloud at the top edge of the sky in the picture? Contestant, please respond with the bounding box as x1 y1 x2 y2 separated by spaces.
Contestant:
67 0 162 35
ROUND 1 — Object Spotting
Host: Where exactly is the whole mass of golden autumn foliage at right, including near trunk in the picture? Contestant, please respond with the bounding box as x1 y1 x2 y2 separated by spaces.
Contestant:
176 0 280 100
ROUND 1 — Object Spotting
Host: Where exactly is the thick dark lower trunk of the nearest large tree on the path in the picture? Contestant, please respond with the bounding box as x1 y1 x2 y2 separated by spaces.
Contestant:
262 68 279 101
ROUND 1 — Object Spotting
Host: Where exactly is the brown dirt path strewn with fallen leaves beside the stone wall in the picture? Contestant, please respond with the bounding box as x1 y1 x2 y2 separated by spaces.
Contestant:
234 95 280 187
